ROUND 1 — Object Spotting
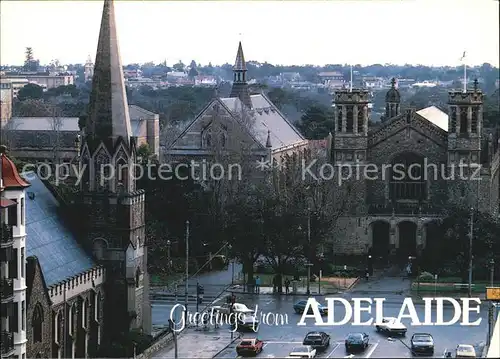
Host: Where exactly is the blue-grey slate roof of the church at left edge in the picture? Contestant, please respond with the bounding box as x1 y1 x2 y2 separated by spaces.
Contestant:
21 172 97 287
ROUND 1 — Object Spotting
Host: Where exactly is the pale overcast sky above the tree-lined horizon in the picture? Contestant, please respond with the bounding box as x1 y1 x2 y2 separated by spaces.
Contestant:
0 0 499 66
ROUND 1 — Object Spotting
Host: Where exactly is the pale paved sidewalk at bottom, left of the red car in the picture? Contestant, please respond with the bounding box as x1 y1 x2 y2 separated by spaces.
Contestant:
151 327 238 359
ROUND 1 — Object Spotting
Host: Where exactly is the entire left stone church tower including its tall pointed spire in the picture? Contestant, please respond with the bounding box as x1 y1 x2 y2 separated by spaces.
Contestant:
75 0 151 340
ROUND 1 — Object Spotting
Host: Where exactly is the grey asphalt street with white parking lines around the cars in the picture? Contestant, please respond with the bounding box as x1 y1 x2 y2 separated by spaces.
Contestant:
212 295 487 358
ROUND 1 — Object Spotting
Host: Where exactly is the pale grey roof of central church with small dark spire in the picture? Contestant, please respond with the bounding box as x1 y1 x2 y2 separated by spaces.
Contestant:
221 94 305 150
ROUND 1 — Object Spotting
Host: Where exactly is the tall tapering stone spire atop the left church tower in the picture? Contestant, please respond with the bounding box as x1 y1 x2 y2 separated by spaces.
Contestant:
86 0 132 144
